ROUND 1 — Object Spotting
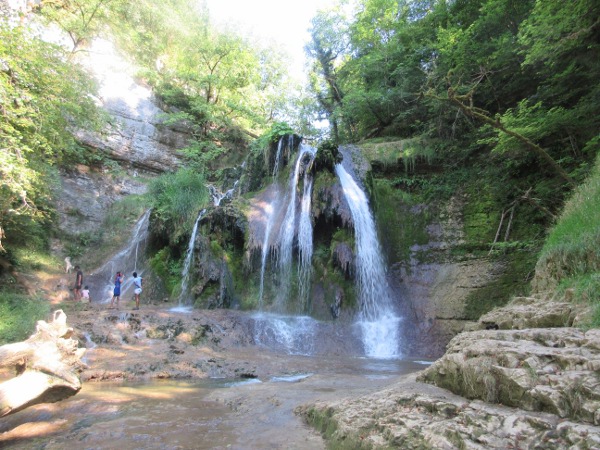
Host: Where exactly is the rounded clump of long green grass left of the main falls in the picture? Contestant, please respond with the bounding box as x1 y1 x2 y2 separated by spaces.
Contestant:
149 169 209 243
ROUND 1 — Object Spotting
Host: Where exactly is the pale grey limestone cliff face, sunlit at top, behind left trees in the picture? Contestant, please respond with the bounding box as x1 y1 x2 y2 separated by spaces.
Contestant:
56 39 190 234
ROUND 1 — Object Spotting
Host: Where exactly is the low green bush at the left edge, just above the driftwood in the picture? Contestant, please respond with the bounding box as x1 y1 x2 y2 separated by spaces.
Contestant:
0 290 50 345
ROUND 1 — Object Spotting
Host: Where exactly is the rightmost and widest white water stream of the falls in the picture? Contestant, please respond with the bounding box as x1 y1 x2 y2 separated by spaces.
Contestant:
335 164 400 358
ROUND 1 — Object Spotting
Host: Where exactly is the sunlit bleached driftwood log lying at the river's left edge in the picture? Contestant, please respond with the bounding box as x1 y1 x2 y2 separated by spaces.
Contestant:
0 310 85 417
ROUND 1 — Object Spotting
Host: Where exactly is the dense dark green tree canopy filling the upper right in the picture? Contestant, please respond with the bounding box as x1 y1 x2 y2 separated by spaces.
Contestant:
308 0 600 218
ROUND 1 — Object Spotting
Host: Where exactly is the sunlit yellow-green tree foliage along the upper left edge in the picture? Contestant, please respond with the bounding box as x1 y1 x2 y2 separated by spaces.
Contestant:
0 22 102 255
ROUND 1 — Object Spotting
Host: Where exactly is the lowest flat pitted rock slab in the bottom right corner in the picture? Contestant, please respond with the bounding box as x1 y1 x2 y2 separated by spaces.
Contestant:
296 376 600 449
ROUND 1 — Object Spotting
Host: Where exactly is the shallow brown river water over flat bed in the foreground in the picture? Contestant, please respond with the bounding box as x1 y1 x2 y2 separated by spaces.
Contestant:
0 349 428 450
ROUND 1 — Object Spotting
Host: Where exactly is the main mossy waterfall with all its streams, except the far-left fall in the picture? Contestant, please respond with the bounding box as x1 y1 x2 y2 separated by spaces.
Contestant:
179 135 403 359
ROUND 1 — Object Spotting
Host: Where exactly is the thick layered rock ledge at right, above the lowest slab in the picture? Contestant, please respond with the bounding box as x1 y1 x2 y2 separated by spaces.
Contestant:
419 328 600 425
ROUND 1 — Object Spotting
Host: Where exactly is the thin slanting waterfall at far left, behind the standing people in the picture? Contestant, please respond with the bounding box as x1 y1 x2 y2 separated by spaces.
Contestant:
88 209 150 303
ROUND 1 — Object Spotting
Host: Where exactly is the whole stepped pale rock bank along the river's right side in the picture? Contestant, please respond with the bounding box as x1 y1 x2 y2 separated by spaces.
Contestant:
298 298 600 449
